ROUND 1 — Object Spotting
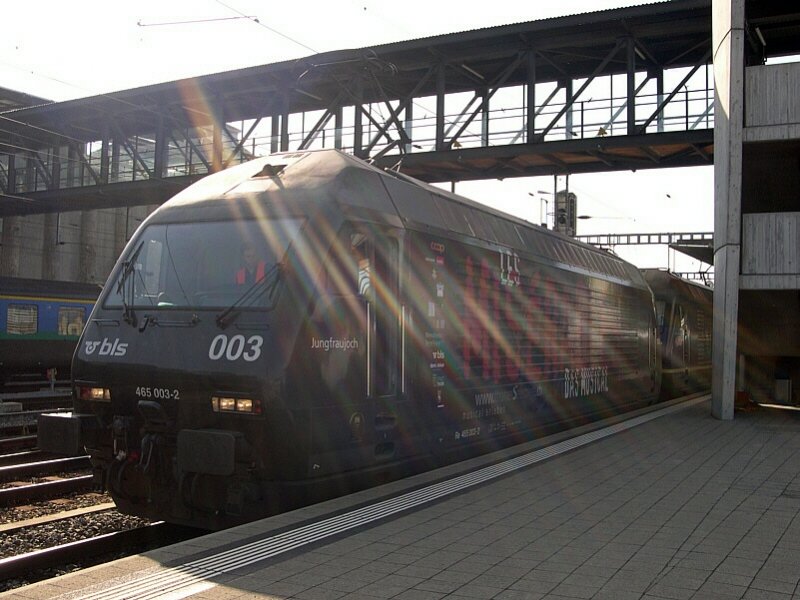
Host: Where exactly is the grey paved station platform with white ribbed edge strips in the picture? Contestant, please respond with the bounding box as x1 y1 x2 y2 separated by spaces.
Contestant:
6 396 800 600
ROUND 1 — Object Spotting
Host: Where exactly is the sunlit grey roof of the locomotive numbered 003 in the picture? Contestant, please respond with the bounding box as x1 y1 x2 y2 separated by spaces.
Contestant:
148 150 645 287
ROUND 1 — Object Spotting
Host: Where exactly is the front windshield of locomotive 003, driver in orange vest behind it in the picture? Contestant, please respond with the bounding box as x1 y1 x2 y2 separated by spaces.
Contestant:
104 218 303 309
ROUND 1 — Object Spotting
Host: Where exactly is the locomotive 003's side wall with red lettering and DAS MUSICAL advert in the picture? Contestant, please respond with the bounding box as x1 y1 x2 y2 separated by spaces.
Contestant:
406 227 657 452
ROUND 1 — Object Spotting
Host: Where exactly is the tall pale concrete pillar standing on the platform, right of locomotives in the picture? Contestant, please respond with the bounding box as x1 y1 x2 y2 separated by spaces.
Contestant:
711 0 745 420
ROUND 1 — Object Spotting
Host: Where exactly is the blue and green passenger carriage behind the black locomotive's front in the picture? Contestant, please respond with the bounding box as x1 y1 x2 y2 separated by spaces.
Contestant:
0 277 100 383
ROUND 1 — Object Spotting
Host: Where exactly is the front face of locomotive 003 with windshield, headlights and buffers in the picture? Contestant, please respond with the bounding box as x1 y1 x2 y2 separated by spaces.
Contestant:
68 215 310 517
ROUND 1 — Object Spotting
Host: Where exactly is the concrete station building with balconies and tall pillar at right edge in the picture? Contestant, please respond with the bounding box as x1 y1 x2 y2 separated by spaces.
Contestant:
712 0 800 419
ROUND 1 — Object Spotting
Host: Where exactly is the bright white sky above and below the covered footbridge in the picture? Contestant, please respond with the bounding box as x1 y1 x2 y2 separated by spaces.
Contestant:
0 0 713 271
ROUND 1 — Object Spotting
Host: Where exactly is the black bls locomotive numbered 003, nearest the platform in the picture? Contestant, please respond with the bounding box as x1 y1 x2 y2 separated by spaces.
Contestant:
40 151 700 528
